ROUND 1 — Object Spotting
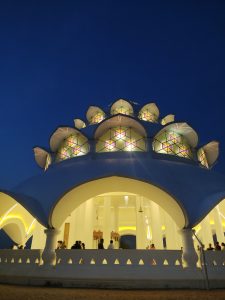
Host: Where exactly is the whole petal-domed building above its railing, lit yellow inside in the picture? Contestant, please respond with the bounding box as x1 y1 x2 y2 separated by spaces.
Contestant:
0 99 225 290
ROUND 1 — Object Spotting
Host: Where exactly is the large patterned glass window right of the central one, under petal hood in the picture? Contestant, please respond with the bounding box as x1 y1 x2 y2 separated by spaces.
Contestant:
152 131 193 159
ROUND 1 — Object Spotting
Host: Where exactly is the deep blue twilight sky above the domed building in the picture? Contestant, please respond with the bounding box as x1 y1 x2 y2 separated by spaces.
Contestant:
0 0 225 188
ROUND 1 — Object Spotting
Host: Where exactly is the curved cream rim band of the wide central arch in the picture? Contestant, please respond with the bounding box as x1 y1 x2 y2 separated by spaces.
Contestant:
49 176 187 228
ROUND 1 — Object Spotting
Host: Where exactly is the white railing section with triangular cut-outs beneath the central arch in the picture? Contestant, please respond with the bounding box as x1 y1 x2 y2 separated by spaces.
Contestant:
56 249 182 267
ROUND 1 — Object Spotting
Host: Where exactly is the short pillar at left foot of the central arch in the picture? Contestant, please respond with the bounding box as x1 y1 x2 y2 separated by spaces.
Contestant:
42 228 60 266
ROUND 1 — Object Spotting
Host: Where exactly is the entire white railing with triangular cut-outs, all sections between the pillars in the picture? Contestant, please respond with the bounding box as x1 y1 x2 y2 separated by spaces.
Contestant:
0 249 225 269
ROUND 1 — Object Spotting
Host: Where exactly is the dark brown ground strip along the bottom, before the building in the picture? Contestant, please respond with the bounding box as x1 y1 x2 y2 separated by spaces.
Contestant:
0 285 225 300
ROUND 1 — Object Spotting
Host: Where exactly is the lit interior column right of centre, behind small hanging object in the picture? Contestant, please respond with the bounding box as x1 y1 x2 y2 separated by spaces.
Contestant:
136 196 147 249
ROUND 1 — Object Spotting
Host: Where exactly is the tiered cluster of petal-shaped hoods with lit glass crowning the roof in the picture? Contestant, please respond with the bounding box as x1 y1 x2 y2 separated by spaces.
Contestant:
34 99 219 170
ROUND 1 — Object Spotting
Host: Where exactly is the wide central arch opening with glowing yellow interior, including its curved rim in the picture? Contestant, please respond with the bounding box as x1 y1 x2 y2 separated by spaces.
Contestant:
49 176 186 249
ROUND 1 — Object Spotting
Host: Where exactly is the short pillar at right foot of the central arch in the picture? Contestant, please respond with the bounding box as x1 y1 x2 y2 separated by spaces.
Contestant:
180 228 198 268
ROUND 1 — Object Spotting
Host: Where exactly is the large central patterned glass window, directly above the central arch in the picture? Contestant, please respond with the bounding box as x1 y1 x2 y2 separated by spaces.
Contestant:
96 126 147 152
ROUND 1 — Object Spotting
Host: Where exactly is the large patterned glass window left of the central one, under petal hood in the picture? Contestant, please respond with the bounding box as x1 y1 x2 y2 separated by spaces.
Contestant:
56 133 89 162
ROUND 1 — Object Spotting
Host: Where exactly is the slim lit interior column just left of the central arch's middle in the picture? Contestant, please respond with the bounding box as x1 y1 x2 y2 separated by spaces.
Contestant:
103 196 112 248
